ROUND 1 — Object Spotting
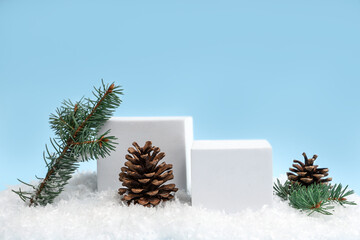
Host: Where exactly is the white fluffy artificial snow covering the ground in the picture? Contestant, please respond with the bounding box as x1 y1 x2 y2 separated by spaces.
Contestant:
0 173 360 240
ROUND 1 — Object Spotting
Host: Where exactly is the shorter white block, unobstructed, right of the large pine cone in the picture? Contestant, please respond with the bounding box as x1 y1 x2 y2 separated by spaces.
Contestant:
191 140 273 212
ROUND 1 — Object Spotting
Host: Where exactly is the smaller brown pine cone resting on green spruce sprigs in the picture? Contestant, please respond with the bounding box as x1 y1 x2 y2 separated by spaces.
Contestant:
287 153 332 186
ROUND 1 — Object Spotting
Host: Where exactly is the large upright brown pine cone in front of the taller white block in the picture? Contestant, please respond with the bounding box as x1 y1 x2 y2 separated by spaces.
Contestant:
119 141 178 207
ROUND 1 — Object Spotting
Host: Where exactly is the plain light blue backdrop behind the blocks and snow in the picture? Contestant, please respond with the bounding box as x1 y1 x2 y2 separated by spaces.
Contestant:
0 0 360 193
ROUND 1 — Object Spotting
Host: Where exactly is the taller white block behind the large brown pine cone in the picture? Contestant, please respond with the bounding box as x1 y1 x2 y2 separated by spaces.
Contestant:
97 117 193 191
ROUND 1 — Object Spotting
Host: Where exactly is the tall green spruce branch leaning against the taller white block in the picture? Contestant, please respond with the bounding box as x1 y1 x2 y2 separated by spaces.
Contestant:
13 82 122 206
